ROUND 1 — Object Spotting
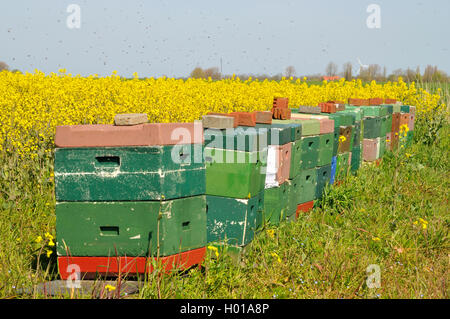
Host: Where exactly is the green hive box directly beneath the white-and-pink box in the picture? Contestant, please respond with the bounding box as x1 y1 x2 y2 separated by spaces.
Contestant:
263 183 289 226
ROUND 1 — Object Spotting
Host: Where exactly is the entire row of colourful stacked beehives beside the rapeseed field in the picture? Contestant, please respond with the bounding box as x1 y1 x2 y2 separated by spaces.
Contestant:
55 98 414 278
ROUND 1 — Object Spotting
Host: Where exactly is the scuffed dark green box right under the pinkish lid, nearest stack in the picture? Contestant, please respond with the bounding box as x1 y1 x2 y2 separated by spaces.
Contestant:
55 144 205 201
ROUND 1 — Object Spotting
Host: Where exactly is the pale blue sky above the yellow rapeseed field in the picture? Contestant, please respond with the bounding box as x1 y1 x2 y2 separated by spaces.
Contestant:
0 0 450 77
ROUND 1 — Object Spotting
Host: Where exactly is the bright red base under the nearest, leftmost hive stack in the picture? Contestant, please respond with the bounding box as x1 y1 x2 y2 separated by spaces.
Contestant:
58 247 206 280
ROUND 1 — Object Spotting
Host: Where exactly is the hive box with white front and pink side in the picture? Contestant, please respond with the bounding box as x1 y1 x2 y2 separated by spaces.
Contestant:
265 142 292 188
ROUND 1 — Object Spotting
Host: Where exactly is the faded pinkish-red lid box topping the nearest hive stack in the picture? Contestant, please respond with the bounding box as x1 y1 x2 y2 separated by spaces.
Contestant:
55 121 203 148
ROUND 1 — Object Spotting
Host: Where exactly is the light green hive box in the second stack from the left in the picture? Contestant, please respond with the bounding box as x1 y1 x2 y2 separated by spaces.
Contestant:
205 147 267 198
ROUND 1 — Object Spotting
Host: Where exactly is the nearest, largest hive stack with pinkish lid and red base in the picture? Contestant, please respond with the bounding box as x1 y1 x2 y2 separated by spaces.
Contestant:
55 121 206 279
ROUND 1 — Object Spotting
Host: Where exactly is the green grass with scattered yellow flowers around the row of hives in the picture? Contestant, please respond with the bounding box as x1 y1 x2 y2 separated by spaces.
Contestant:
0 90 450 298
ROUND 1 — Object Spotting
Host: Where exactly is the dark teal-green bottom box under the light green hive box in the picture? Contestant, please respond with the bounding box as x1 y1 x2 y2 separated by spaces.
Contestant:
206 191 264 246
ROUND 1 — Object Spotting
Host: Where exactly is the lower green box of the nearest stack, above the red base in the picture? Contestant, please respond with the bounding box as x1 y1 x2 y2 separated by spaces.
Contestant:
56 195 206 258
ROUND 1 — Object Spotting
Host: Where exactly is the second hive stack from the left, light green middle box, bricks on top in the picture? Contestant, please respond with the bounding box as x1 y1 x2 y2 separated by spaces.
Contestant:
203 112 272 252
